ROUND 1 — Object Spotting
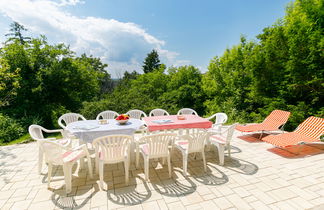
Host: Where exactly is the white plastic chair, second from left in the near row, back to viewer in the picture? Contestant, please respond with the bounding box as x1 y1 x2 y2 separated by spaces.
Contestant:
92 135 133 189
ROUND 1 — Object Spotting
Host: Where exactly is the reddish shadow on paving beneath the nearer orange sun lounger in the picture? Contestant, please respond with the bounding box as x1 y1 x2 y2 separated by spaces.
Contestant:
267 145 324 158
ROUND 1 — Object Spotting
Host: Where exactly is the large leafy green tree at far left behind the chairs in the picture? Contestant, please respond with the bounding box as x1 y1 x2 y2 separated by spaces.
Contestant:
0 28 110 133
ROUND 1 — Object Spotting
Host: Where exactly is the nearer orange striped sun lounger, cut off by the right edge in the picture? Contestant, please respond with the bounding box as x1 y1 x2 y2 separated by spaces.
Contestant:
262 116 324 147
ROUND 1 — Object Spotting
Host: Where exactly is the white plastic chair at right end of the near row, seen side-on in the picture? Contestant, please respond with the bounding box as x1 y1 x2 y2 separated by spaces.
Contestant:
209 123 238 165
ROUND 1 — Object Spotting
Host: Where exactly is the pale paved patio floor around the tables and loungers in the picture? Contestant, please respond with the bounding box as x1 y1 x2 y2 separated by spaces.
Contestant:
0 132 324 210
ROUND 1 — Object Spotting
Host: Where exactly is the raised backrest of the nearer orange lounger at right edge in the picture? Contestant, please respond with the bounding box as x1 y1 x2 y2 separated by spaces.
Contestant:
295 116 324 139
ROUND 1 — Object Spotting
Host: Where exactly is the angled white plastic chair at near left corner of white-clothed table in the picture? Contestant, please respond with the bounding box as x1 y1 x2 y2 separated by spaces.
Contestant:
39 140 93 193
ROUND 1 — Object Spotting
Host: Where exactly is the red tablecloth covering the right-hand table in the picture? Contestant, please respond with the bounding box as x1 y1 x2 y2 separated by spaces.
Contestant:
143 115 213 131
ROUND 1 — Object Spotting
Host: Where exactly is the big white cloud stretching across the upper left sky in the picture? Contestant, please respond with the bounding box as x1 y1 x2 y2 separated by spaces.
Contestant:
0 0 190 77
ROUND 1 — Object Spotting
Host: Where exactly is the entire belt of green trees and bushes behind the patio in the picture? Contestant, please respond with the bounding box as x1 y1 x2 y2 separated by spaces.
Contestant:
0 0 324 141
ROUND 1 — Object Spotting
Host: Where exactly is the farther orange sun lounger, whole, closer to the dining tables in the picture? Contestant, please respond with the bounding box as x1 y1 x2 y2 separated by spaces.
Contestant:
236 110 290 138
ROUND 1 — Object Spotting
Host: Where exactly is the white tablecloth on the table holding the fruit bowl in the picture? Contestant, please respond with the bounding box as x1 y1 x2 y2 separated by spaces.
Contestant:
66 119 144 143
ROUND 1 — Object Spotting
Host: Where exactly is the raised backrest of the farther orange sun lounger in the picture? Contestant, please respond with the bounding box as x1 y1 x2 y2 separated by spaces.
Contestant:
262 110 290 129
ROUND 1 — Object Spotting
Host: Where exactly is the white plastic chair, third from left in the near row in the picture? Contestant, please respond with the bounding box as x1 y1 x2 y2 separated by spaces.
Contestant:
136 133 176 180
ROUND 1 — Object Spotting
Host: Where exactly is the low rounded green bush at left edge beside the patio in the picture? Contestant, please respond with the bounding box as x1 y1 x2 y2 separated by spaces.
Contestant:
0 113 24 143
